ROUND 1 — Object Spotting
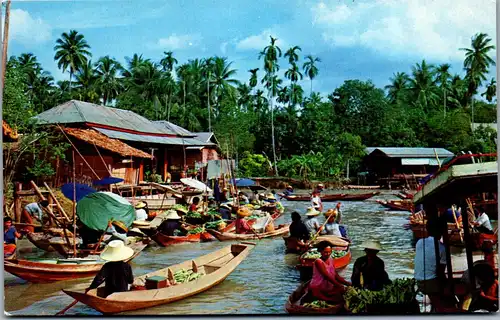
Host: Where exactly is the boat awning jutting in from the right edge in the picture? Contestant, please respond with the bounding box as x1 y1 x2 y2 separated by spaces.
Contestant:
413 161 498 204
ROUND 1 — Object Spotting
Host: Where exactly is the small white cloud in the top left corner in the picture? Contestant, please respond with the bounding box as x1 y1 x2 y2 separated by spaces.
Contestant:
9 9 52 45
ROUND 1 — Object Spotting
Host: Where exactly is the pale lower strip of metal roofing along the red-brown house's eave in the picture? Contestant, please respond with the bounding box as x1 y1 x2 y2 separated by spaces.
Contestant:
94 128 214 146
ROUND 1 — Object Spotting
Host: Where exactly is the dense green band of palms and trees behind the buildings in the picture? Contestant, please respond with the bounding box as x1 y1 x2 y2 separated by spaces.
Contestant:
4 30 496 179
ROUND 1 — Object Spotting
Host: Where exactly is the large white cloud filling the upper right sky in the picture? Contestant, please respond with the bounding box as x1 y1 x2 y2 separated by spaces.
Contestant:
311 0 496 61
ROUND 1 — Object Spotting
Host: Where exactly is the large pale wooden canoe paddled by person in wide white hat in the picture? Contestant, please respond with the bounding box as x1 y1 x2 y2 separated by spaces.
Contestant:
63 243 255 315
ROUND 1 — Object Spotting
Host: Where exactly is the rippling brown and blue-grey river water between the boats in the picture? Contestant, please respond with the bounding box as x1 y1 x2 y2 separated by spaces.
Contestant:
0 192 480 315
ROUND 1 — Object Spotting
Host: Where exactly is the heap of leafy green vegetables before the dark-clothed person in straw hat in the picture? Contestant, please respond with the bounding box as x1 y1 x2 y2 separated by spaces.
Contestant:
344 278 417 313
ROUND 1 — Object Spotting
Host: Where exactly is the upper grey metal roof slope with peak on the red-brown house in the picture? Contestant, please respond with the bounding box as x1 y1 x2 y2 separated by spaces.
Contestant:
34 100 176 134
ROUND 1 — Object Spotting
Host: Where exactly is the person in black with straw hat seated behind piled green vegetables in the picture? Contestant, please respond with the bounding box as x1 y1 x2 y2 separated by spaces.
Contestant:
351 240 391 291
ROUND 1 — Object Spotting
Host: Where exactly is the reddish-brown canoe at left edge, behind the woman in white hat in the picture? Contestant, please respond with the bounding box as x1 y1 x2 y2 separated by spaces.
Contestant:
4 245 146 283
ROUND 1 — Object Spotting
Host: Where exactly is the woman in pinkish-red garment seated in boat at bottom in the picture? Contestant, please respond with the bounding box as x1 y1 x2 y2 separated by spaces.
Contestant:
309 241 351 303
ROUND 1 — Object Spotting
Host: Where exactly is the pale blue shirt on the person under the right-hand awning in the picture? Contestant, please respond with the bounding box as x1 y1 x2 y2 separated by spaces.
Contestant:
415 237 446 281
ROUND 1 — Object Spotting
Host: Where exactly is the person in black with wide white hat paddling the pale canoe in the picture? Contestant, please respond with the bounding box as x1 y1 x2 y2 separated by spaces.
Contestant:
85 240 134 296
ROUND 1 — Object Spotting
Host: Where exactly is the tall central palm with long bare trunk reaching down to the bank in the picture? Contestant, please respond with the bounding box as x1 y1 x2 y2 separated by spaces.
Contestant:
259 36 282 176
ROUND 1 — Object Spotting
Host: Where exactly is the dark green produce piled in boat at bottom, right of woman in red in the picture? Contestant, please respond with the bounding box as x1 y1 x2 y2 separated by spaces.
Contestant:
344 278 420 315
